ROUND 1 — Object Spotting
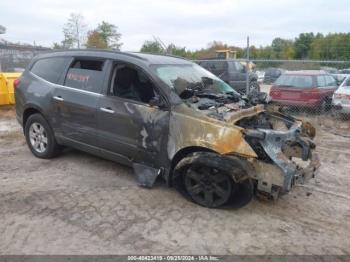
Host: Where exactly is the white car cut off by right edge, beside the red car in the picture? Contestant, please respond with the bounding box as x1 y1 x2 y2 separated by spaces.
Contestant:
332 76 350 114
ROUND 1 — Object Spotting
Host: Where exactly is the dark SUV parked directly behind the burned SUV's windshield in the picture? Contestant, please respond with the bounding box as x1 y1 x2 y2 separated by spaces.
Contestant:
197 60 260 94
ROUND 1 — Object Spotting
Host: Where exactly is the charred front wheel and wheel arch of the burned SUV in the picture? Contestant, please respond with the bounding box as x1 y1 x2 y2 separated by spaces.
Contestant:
174 152 253 208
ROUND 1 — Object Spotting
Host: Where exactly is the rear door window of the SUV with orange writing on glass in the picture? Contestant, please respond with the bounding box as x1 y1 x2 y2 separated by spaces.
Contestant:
64 59 104 93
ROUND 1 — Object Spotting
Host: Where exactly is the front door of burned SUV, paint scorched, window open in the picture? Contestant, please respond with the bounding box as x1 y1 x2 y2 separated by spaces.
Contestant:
97 63 169 166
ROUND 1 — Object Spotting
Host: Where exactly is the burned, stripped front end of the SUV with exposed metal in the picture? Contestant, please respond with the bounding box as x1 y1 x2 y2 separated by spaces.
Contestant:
235 110 320 199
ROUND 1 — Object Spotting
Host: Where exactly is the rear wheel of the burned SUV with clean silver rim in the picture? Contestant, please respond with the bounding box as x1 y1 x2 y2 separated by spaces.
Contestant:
24 114 61 159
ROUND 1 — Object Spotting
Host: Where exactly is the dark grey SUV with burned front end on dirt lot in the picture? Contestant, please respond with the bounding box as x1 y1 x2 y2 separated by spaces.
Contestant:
15 50 319 208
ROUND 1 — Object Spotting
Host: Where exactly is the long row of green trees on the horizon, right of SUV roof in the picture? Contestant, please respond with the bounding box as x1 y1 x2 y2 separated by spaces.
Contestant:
140 33 350 60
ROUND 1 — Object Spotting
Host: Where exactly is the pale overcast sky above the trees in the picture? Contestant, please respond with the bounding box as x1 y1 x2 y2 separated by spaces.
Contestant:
0 0 350 51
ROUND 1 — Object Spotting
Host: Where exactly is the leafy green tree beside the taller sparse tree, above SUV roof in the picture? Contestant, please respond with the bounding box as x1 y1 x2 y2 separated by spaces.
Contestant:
96 21 122 50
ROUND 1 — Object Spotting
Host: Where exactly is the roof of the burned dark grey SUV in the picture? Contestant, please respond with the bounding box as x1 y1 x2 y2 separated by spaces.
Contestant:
36 49 192 64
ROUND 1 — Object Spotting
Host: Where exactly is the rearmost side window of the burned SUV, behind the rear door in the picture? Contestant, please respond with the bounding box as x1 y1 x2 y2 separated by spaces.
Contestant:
30 57 69 84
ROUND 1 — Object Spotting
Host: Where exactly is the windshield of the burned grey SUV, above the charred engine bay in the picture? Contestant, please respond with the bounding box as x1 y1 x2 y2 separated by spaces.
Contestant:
153 64 240 97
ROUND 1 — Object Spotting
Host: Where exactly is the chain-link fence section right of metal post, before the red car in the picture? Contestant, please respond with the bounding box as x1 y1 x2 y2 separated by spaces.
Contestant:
252 60 350 131
